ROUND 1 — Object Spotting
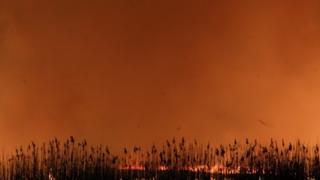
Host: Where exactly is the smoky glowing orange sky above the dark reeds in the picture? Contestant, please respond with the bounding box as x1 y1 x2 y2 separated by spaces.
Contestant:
0 0 320 149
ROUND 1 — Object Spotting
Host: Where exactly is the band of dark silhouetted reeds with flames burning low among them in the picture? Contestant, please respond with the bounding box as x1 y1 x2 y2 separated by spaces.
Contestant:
0 137 320 180
